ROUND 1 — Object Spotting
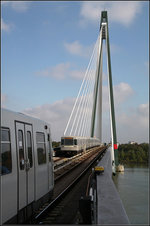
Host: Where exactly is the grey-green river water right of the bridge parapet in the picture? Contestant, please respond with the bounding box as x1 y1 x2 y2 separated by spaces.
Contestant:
113 165 149 225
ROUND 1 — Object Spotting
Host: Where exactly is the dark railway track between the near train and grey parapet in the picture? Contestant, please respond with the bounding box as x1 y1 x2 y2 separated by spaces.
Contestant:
30 147 106 224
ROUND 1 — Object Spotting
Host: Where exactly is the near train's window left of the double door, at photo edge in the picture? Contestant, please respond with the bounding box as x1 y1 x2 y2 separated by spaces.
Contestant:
1 128 12 175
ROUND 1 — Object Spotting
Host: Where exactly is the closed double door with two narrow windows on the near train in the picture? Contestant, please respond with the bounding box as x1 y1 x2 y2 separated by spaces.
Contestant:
16 122 34 209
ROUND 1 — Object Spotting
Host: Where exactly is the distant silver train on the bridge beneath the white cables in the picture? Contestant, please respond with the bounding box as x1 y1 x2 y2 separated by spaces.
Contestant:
56 136 101 156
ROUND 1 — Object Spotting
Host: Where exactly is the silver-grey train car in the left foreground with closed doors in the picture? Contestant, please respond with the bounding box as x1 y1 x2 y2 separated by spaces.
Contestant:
0 109 54 224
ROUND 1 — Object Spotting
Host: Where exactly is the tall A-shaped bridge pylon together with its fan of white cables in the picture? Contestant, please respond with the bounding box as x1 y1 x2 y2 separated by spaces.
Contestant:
64 11 118 165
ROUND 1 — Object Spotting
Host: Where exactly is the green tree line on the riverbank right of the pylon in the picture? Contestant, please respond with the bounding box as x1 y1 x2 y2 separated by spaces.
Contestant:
118 143 149 163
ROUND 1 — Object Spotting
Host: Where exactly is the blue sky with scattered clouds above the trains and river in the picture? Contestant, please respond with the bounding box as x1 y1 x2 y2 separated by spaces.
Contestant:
1 1 149 143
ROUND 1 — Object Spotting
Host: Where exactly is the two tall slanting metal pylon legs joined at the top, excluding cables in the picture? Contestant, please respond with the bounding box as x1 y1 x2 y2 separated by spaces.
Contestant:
91 11 118 166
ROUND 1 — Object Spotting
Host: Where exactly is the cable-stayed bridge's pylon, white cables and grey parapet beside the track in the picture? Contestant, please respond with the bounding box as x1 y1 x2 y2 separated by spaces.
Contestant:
60 11 129 225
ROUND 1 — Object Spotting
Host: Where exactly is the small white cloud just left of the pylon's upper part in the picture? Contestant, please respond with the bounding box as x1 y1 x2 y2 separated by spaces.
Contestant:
64 41 93 57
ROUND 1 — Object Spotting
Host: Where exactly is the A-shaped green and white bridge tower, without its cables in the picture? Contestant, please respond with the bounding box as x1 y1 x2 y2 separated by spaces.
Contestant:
91 11 118 166
